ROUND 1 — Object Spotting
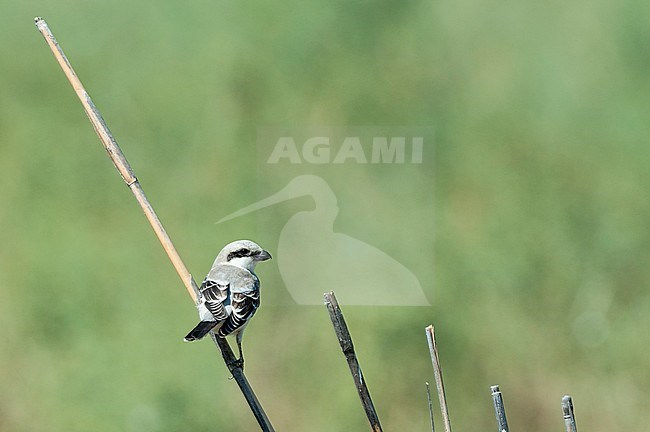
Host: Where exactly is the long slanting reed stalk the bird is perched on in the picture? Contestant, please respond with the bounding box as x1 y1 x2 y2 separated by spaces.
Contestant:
34 17 274 432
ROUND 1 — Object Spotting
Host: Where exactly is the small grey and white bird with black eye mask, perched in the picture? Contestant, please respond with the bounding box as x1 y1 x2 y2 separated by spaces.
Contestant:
185 240 271 367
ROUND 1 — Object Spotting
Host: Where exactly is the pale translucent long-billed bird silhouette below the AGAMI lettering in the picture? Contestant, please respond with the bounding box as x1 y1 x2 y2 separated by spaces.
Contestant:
217 175 429 306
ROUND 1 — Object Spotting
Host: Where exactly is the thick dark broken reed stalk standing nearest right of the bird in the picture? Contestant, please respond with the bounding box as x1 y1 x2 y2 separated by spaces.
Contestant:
323 292 382 432
